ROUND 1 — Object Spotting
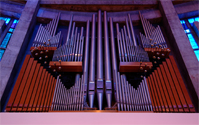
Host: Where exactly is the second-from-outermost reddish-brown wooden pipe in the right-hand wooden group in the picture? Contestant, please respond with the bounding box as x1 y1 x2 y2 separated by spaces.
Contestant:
166 59 189 112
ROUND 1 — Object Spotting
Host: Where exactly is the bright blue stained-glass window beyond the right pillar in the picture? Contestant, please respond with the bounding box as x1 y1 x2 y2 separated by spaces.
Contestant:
180 17 199 61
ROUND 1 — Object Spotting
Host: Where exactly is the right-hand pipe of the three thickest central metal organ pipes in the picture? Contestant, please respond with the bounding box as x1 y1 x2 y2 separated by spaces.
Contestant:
104 11 112 108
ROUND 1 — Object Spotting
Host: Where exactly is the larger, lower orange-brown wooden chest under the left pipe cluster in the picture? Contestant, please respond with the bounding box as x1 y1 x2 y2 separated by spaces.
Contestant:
49 61 82 72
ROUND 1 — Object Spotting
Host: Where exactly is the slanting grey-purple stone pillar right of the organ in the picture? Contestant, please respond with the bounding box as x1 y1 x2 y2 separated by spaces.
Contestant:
159 0 199 100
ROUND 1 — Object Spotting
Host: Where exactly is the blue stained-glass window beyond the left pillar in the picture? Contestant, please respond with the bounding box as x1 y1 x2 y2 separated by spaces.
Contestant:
0 17 18 61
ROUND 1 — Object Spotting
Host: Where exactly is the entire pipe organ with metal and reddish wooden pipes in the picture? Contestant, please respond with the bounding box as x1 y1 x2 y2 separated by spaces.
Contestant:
6 10 195 112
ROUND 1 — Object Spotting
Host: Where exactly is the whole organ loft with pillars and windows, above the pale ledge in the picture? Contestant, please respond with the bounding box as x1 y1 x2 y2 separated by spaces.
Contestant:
0 0 199 124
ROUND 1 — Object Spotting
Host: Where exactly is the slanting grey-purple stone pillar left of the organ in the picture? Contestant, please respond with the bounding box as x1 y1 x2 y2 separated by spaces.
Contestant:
0 0 39 101
